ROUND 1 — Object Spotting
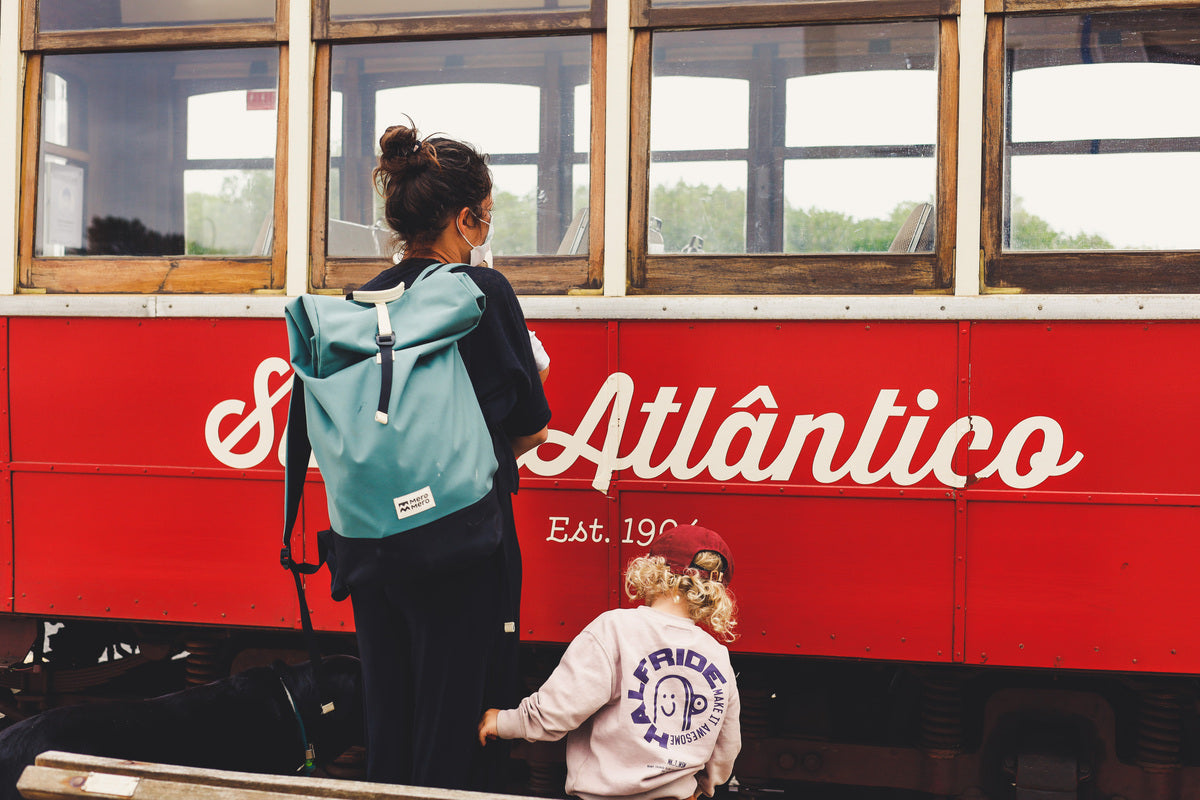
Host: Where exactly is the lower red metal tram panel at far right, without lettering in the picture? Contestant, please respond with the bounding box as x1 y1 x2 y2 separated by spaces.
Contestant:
966 503 1200 673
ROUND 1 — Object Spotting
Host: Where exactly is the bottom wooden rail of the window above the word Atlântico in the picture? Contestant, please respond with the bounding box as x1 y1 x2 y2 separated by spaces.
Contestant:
630 253 937 295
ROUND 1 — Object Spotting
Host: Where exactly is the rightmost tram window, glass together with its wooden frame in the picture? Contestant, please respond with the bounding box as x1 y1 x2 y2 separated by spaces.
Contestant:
983 8 1200 293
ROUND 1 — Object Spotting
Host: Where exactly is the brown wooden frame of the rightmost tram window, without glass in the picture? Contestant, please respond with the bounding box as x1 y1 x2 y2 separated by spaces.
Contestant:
980 9 1200 294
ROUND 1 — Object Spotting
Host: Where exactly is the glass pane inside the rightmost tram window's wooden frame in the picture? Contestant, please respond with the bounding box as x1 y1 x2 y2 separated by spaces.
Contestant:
1003 11 1200 251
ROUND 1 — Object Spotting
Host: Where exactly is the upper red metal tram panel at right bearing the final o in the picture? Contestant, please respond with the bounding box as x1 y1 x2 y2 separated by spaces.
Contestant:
971 321 1200 501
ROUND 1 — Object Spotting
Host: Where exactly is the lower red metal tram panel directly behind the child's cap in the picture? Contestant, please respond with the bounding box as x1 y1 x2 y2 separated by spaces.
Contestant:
622 493 954 661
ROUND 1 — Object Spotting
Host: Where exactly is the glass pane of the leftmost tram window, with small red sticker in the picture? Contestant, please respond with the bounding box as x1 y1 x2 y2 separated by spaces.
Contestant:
35 48 278 255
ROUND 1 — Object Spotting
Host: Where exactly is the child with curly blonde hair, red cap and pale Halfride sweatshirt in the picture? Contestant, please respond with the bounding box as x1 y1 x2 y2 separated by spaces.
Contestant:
479 525 742 800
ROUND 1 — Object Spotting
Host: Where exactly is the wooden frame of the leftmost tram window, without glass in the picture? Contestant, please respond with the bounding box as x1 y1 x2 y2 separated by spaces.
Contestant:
17 0 288 294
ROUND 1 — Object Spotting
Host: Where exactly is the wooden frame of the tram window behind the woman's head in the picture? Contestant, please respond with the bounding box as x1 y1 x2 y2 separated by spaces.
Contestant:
310 26 606 295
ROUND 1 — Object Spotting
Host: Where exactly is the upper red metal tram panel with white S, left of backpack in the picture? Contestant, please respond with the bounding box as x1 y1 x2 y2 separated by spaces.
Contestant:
10 318 289 470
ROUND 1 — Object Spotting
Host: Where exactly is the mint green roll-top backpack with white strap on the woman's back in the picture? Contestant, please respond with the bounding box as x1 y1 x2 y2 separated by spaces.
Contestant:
281 264 500 582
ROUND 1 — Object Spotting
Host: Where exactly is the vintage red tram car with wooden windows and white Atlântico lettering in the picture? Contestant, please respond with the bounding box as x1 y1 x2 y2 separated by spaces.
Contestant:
0 0 1200 800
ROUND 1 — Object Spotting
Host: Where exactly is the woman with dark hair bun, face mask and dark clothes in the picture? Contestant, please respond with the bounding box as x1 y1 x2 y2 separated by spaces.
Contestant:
334 121 550 790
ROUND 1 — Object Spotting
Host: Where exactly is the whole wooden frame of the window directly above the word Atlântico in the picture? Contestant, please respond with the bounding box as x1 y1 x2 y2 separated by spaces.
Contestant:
628 15 959 295
